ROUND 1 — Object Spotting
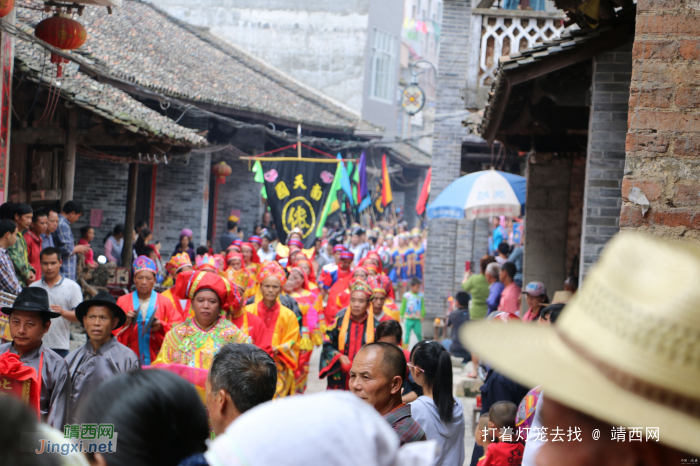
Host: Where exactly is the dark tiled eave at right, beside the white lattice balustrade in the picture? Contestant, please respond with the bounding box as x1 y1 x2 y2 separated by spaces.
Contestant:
478 18 626 142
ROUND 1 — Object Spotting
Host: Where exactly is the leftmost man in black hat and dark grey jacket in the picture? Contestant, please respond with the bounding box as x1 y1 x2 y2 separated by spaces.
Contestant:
0 288 71 431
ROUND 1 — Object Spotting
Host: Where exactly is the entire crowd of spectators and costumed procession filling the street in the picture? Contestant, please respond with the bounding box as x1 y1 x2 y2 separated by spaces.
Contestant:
0 201 700 466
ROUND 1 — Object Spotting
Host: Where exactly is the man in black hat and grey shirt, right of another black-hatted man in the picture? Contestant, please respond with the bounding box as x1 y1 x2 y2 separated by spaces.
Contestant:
66 291 141 416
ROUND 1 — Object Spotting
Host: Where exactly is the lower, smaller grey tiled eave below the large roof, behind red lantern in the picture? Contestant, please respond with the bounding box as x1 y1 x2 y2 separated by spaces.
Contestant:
15 28 207 146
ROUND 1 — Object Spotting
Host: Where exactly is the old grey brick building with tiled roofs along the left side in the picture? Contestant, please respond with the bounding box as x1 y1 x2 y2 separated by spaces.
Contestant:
10 0 382 259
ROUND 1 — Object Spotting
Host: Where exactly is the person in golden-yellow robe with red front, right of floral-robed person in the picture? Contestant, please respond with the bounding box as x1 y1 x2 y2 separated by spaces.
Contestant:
245 262 300 398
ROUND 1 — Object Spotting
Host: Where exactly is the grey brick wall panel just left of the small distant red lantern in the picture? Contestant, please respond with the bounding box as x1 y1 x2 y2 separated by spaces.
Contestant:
153 154 211 261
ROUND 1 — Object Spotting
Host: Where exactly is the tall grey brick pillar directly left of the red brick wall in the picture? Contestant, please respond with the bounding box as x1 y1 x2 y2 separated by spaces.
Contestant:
579 43 632 279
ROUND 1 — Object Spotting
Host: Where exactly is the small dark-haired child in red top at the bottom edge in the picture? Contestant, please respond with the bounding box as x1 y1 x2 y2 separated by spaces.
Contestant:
478 401 525 466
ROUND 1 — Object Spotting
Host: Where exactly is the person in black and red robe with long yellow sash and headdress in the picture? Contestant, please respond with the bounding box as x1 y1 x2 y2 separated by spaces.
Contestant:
318 279 379 390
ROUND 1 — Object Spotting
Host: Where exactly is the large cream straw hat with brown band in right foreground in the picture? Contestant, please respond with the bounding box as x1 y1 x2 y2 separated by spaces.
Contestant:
461 233 700 455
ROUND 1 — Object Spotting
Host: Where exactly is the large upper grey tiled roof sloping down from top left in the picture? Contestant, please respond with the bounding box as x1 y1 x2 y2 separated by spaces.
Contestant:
13 0 378 132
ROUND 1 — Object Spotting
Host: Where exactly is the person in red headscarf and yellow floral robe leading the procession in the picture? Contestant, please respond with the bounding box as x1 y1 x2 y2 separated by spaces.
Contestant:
153 272 251 400
